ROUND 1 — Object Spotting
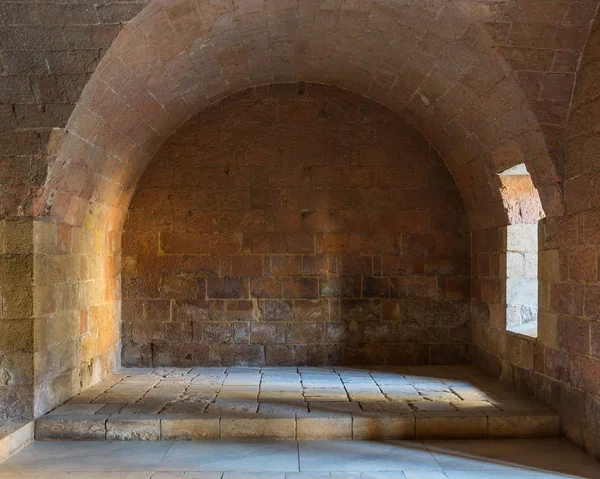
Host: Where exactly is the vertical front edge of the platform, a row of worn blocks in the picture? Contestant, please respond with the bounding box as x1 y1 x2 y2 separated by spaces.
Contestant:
35 408 559 441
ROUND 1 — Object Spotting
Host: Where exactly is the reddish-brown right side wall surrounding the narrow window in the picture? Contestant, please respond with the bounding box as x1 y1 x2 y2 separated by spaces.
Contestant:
473 17 600 458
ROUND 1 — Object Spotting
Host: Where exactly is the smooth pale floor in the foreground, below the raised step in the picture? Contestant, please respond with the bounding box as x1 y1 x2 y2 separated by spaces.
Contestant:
0 439 600 479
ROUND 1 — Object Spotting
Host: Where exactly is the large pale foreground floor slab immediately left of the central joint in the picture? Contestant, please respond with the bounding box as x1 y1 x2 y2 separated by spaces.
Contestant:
158 441 298 472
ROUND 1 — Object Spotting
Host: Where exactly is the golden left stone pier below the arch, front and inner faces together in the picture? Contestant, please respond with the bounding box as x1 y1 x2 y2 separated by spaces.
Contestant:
0 219 120 418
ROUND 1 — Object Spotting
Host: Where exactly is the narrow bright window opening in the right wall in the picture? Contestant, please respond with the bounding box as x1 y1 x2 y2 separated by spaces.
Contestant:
500 164 544 337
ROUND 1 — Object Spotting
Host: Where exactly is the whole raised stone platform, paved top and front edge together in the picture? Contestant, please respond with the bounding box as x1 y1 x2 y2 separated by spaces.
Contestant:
35 366 559 440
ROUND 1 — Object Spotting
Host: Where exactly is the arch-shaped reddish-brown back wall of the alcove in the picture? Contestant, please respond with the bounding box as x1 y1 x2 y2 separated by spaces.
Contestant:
122 84 470 366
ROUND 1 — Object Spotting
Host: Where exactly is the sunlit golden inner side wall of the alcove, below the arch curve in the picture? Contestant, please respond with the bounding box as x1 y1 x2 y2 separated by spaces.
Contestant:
33 222 120 415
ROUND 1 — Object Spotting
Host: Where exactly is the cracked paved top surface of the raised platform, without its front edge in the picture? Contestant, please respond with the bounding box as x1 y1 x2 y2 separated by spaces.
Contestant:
56 366 542 414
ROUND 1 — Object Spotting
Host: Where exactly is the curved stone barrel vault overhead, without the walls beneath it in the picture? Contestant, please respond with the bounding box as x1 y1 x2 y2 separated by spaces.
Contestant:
34 0 561 229
